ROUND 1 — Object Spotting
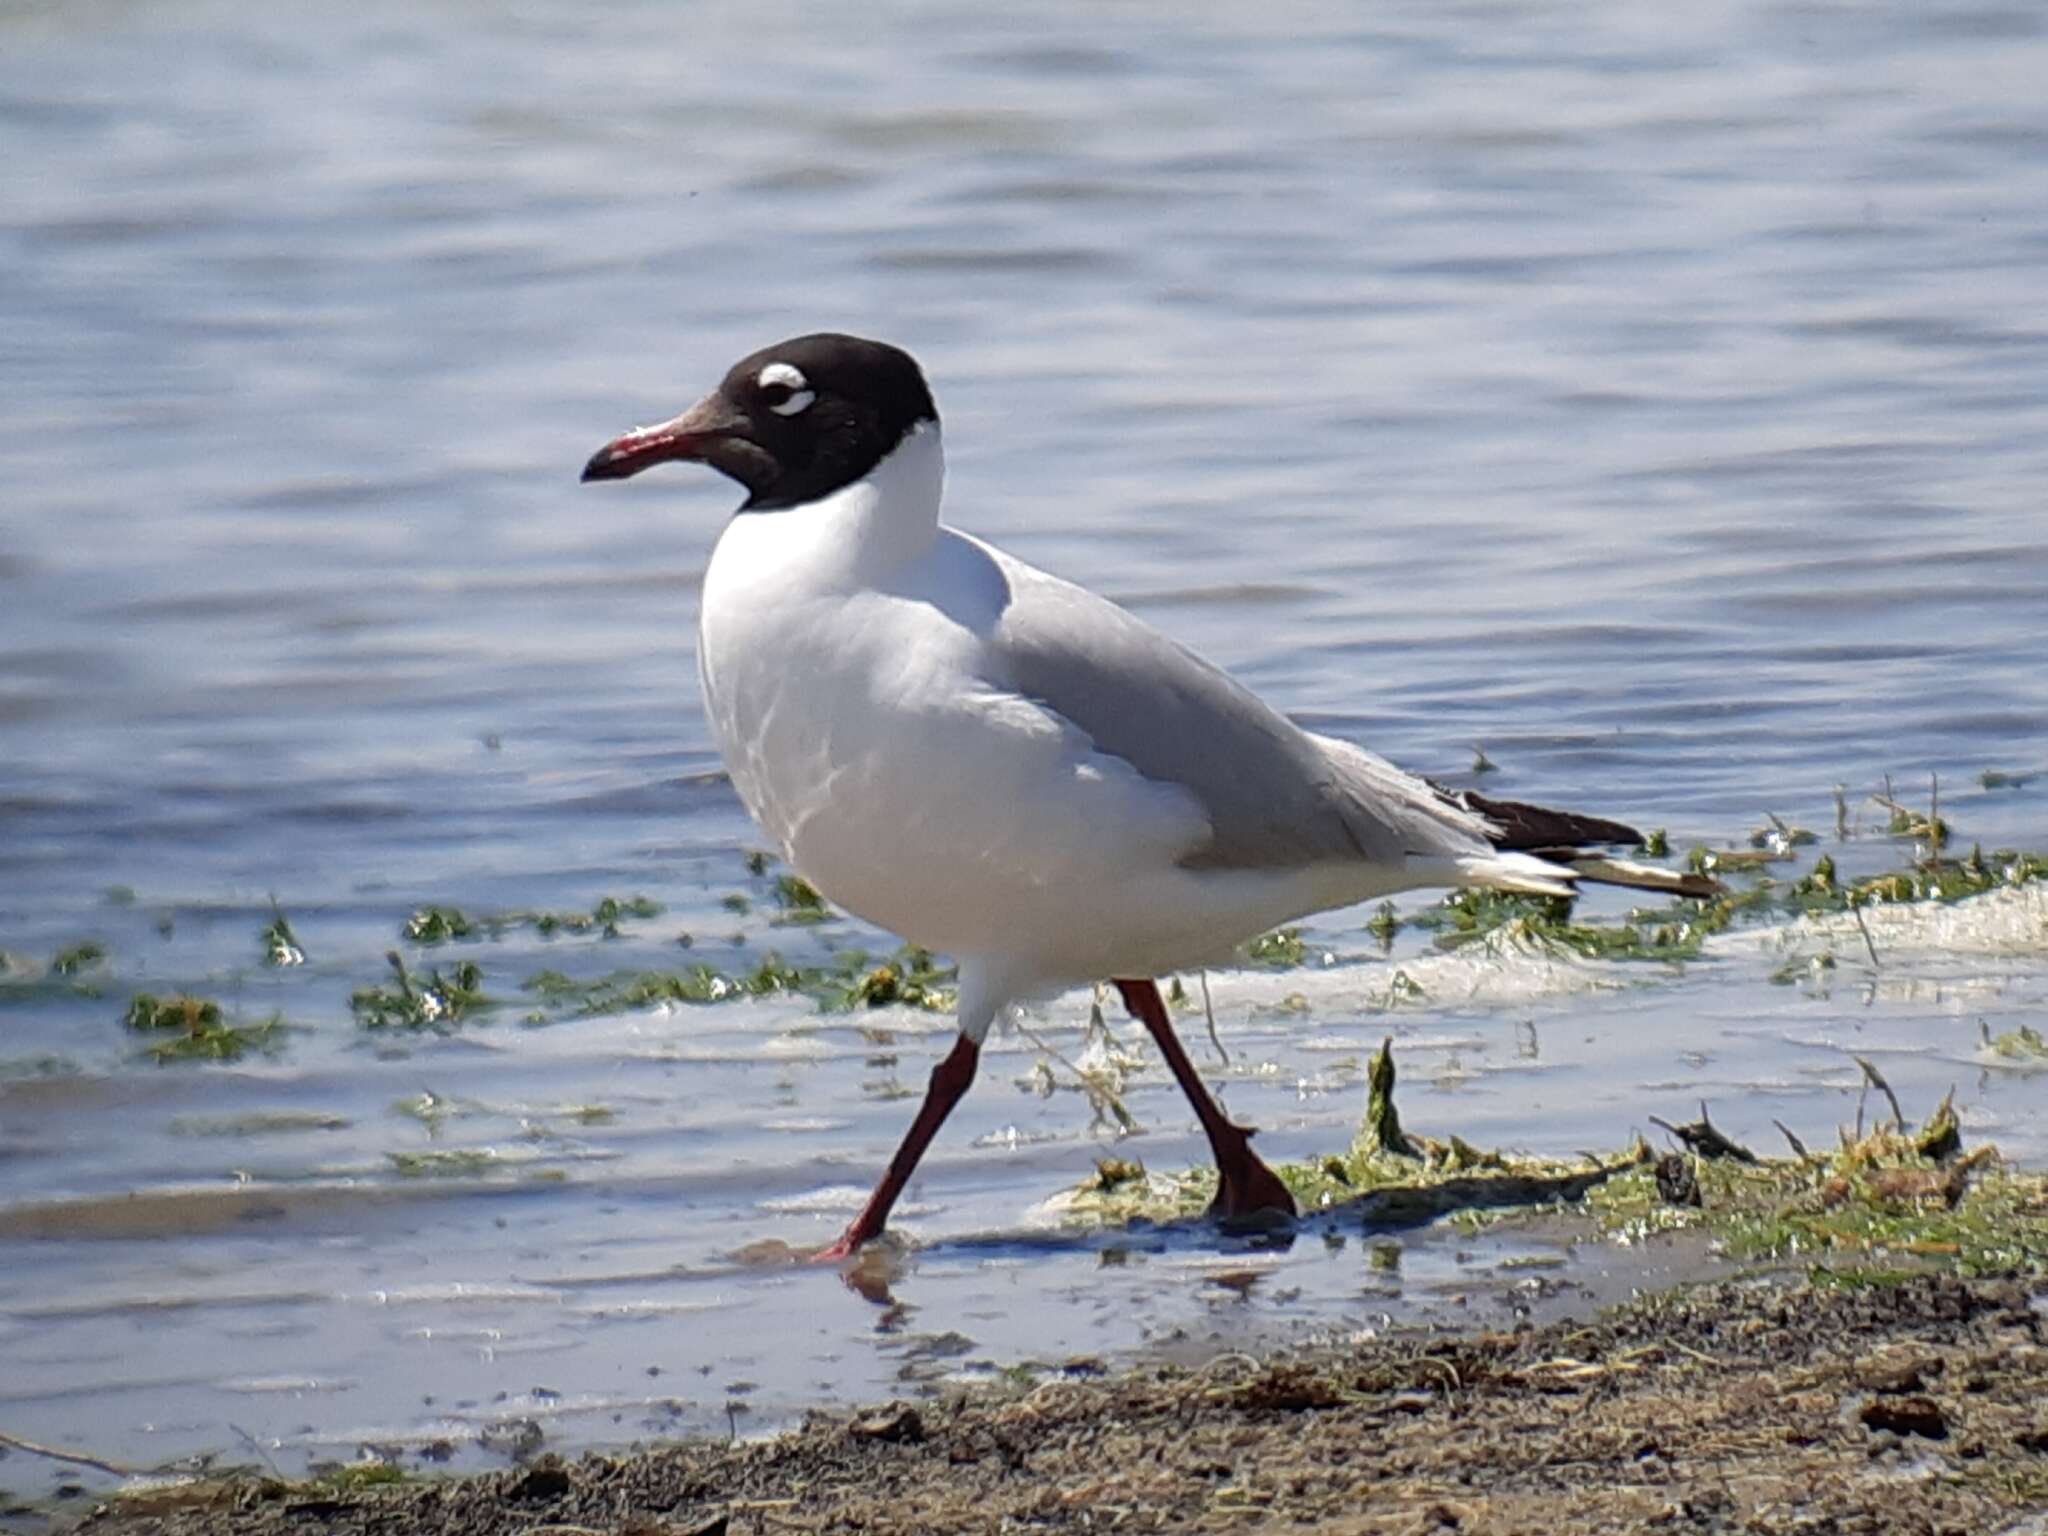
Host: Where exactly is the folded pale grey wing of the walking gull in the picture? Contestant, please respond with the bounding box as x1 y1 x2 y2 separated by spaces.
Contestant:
989 549 1487 868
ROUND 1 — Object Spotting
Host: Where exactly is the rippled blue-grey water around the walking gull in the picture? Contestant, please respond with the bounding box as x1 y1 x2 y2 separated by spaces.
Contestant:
0 0 2048 1491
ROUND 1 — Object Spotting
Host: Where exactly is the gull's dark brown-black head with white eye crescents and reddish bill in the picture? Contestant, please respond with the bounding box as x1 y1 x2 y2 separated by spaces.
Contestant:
584 332 938 512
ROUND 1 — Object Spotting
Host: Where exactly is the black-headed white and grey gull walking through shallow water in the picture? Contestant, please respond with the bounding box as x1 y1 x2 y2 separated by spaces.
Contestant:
584 334 1710 1260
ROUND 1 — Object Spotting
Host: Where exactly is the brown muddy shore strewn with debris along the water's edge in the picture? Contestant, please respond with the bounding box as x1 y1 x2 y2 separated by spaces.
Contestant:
51 1274 2048 1536
